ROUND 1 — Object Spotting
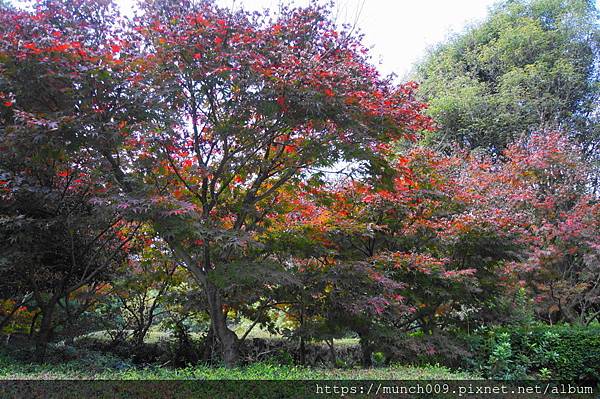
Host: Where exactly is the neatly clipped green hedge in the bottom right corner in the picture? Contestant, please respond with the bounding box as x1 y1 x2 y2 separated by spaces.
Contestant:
472 325 600 383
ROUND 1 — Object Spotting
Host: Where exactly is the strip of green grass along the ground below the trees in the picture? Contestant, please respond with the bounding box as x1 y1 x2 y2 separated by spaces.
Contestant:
0 353 478 380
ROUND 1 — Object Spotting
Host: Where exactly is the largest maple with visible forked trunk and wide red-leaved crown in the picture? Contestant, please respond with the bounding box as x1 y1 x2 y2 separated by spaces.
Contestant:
0 0 431 365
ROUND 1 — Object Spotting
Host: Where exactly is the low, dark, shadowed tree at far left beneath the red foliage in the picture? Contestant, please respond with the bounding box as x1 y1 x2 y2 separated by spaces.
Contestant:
0 167 135 361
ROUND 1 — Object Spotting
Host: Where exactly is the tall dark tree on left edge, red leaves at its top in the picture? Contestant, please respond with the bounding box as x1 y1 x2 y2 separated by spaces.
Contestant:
0 2 139 360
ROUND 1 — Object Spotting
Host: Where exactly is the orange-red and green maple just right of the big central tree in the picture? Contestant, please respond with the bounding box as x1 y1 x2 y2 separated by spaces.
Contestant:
268 148 518 346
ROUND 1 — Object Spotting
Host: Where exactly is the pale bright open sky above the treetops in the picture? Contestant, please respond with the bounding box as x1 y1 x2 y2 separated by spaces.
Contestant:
117 0 502 79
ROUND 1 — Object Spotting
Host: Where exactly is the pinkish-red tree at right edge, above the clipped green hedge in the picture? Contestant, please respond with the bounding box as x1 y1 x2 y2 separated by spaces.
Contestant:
494 133 600 324
